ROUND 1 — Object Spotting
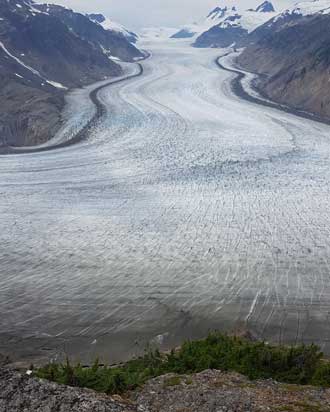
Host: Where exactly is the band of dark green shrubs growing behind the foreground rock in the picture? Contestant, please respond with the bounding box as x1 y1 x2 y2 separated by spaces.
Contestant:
36 332 330 394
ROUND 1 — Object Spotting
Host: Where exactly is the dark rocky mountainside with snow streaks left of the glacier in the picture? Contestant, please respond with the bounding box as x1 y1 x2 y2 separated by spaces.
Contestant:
0 0 141 150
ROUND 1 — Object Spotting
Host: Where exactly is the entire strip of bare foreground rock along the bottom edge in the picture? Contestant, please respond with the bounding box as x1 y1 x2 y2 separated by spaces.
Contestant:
0 367 330 412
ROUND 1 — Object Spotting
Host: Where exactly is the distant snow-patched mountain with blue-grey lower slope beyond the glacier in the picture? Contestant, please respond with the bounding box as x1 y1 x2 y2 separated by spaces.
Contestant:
194 1 276 47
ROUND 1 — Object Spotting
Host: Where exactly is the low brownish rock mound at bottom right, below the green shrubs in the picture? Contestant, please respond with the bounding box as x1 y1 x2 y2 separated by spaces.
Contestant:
136 370 330 412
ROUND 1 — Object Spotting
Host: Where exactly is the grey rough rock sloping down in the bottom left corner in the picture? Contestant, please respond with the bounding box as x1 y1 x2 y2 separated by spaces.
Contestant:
0 369 136 412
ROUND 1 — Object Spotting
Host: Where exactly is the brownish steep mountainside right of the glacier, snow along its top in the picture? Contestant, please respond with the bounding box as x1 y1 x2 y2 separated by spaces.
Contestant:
238 0 330 117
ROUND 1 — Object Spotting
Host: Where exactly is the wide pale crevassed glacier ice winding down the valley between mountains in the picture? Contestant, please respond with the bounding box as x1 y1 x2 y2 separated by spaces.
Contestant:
0 39 330 361
